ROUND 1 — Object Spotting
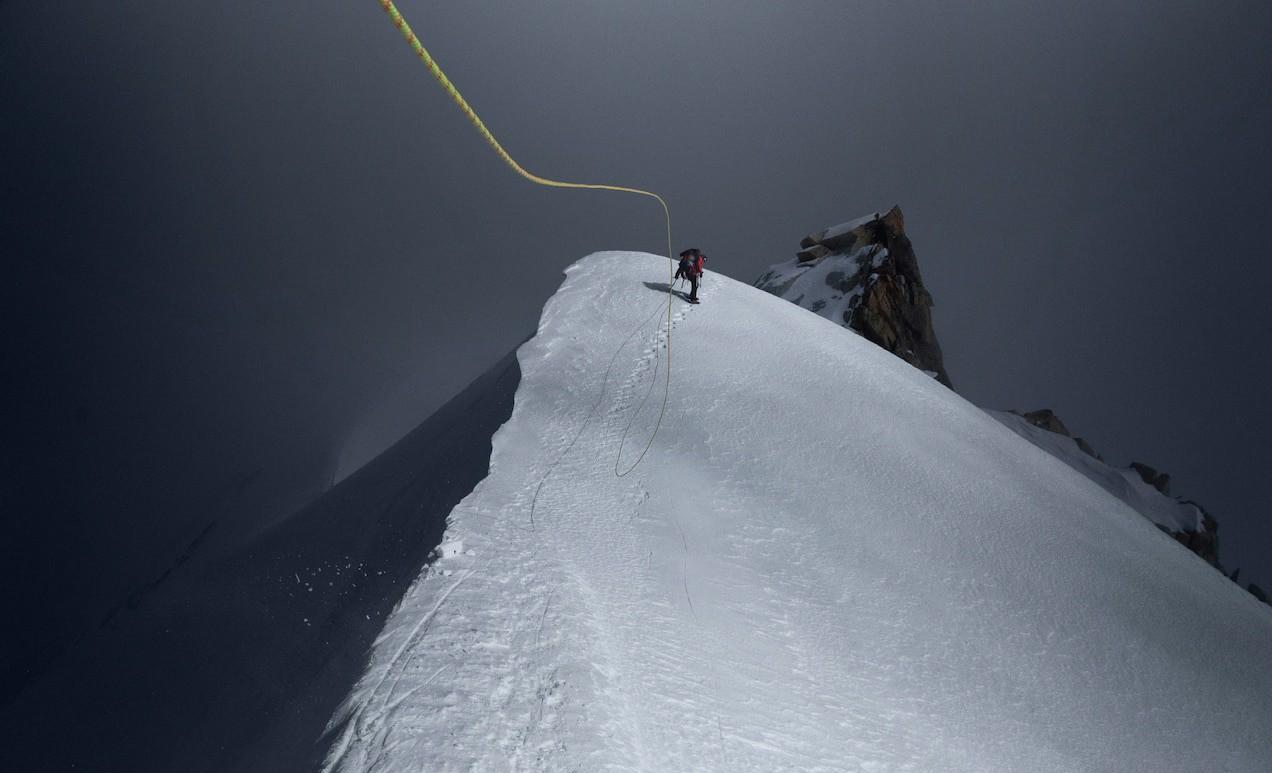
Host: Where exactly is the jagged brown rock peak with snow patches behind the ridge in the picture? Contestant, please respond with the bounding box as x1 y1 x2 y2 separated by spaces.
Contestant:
756 207 953 388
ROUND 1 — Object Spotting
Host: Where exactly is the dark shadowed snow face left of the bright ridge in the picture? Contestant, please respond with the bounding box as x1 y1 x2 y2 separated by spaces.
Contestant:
0 353 520 773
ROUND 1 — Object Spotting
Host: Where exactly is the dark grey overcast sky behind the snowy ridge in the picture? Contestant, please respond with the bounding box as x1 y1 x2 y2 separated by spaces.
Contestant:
0 0 1272 696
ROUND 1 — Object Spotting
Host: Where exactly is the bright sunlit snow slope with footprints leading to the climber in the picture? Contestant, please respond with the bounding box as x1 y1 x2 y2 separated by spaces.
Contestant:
328 253 1272 773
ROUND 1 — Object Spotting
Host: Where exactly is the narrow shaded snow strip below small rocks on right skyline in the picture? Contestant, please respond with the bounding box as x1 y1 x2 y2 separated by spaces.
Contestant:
988 411 1205 531
